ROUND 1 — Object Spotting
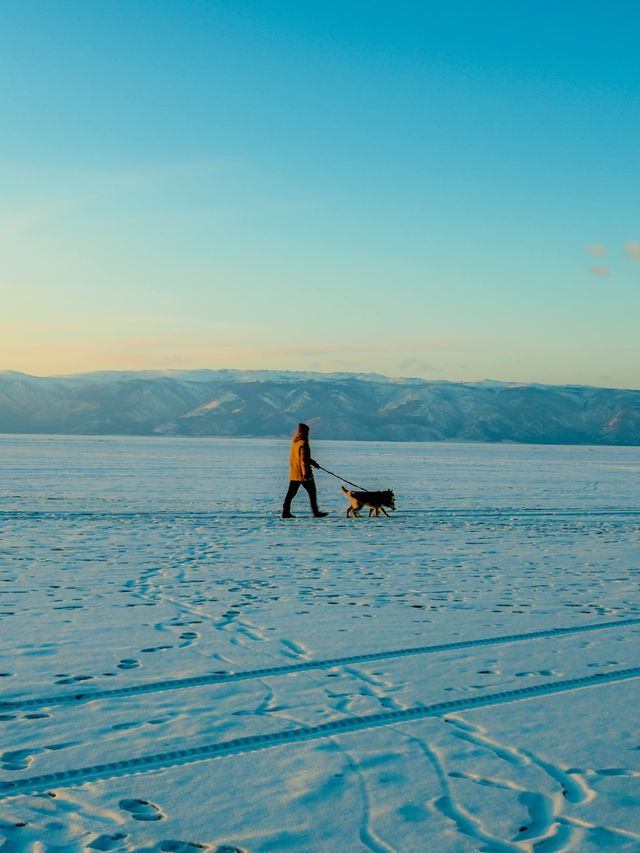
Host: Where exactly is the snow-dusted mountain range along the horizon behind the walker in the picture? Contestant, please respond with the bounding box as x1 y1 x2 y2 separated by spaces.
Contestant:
0 370 640 445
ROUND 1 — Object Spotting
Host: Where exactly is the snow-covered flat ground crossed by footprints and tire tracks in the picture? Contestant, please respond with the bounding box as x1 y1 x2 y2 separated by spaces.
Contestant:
0 436 640 853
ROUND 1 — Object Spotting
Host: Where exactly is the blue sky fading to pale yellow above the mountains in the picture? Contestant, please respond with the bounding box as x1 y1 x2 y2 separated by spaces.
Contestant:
0 0 640 388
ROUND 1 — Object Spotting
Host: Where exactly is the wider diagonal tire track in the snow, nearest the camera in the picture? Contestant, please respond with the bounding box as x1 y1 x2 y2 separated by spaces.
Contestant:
0 666 640 800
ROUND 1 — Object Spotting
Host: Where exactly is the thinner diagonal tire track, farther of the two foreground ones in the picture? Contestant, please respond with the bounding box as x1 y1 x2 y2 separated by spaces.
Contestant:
0 617 640 711
